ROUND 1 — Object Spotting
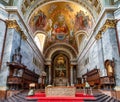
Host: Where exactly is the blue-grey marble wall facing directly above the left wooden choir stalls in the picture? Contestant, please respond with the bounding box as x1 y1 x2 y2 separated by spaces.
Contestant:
11 31 40 74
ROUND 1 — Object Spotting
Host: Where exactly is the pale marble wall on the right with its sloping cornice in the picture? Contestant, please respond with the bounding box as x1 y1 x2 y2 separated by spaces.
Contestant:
77 9 118 80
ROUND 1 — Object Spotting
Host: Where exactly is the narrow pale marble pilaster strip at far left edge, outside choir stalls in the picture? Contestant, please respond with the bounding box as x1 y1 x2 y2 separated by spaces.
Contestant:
0 28 14 89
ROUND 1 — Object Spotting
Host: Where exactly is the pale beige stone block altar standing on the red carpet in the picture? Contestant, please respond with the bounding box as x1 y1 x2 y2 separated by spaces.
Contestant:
45 86 76 97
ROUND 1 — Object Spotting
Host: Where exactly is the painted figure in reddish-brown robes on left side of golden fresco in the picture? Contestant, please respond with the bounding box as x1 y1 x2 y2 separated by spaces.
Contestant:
34 10 46 29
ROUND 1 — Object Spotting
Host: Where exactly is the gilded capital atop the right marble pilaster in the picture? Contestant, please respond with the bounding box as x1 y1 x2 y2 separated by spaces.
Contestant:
101 19 116 32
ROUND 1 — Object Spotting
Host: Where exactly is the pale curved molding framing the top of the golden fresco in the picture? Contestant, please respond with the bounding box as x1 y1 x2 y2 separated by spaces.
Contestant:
26 0 97 22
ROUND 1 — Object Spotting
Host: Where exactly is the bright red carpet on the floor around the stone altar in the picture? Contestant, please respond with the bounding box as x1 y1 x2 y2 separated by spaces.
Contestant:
26 92 95 102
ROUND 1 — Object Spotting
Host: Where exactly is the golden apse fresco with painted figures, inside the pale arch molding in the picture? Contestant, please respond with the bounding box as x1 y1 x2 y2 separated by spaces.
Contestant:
29 2 94 51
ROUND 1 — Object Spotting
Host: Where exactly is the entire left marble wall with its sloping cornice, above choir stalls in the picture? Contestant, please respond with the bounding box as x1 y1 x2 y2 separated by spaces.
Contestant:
0 8 44 90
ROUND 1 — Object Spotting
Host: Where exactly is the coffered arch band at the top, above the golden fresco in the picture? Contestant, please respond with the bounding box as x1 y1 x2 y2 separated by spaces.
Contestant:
21 0 102 20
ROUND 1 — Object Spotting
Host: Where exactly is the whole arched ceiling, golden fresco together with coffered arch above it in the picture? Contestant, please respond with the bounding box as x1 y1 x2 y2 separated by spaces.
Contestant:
21 0 102 55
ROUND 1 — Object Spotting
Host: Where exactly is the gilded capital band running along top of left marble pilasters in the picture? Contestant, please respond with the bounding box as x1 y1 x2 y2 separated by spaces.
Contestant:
6 20 27 40
